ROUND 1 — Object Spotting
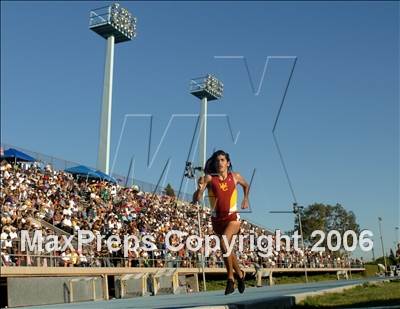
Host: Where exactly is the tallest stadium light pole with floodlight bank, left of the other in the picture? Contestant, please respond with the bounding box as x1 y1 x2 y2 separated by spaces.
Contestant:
89 3 136 174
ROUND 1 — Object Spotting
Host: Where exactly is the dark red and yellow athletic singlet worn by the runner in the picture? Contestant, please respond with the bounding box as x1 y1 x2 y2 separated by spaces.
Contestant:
208 172 237 218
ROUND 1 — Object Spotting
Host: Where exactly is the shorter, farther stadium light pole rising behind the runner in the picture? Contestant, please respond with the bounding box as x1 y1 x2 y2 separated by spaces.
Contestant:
189 74 224 291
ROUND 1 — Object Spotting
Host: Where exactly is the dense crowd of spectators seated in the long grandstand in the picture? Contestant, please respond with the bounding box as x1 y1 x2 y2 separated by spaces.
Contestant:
0 161 360 268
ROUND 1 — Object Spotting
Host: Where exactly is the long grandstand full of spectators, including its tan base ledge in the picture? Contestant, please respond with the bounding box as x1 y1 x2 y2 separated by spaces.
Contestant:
0 146 362 305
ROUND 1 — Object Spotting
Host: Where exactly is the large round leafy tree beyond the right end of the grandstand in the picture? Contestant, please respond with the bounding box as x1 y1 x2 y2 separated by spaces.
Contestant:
295 203 360 255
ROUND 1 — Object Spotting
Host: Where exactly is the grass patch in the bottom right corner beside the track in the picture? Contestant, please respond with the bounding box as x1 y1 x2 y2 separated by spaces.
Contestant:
295 280 400 309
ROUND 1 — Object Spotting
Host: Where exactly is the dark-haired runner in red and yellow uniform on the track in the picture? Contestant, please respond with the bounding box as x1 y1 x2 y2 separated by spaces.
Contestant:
193 150 249 295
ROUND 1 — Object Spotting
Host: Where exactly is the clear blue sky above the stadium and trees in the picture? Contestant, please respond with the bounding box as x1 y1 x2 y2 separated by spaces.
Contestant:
1 1 400 258
